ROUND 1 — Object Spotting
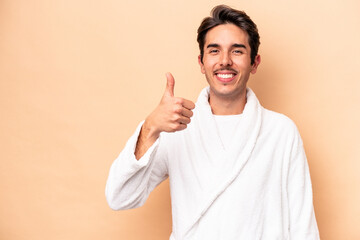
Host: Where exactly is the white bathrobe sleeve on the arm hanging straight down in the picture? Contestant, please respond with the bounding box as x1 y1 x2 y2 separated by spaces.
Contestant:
288 127 320 240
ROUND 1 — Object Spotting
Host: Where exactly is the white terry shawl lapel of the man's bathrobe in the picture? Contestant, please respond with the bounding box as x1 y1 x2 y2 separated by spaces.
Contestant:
184 87 262 238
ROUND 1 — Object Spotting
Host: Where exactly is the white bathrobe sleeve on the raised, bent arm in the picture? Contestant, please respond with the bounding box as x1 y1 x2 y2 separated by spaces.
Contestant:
105 122 168 210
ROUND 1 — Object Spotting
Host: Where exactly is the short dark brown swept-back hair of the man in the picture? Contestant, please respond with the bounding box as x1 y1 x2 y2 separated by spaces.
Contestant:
197 5 260 64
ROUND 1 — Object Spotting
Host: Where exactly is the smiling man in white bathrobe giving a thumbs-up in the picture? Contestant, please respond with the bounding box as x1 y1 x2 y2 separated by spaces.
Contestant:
106 5 319 240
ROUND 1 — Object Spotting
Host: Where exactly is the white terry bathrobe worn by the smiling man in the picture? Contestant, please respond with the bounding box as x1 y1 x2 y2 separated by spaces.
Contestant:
106 87 319 240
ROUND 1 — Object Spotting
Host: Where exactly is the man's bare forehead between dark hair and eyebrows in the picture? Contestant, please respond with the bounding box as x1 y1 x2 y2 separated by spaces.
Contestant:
205 23 249 48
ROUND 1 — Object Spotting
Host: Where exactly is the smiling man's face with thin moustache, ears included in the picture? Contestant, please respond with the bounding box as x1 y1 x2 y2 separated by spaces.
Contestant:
199 24 260 99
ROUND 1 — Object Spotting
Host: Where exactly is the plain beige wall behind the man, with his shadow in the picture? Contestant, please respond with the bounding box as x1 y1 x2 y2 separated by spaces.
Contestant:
0 0 360 240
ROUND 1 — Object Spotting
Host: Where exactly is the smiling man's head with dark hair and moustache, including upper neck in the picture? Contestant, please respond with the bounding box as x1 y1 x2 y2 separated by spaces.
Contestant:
198 5 261 104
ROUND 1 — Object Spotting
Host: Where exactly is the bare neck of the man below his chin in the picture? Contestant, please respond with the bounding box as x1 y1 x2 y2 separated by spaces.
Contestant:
209 89 246 115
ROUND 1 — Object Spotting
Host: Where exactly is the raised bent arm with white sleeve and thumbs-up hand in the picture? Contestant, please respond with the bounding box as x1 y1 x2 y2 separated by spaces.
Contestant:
105 74 195 210
